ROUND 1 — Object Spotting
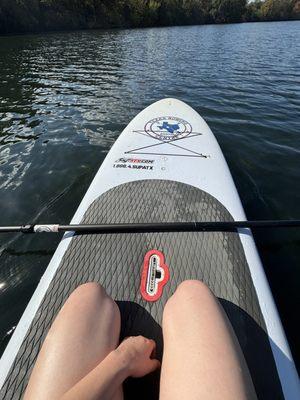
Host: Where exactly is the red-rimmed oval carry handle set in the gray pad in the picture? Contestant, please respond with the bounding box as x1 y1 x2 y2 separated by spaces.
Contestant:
140 250 170 301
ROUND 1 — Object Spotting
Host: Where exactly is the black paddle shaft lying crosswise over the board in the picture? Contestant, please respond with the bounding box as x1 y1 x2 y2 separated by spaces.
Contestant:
0 220 300 235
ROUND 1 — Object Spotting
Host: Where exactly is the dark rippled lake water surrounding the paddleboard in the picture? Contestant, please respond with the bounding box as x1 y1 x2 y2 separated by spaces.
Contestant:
0 22 300 366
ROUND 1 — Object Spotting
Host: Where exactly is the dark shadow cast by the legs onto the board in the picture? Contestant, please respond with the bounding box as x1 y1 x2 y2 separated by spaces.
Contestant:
118 299 290 400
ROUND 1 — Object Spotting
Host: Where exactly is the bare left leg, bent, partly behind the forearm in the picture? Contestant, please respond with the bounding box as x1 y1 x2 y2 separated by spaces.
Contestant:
24 283 123 400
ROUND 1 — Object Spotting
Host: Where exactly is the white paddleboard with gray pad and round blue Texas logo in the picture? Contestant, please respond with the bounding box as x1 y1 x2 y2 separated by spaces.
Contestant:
0 99 300 399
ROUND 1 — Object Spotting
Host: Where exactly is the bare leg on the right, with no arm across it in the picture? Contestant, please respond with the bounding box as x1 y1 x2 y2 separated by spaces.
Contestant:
160 281 256 400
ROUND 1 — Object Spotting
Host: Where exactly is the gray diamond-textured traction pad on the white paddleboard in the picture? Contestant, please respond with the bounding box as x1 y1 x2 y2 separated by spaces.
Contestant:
0 180 282 400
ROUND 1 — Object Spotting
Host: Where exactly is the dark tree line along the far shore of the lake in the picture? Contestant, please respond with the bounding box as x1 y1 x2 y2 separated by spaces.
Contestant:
0 0 300 33
